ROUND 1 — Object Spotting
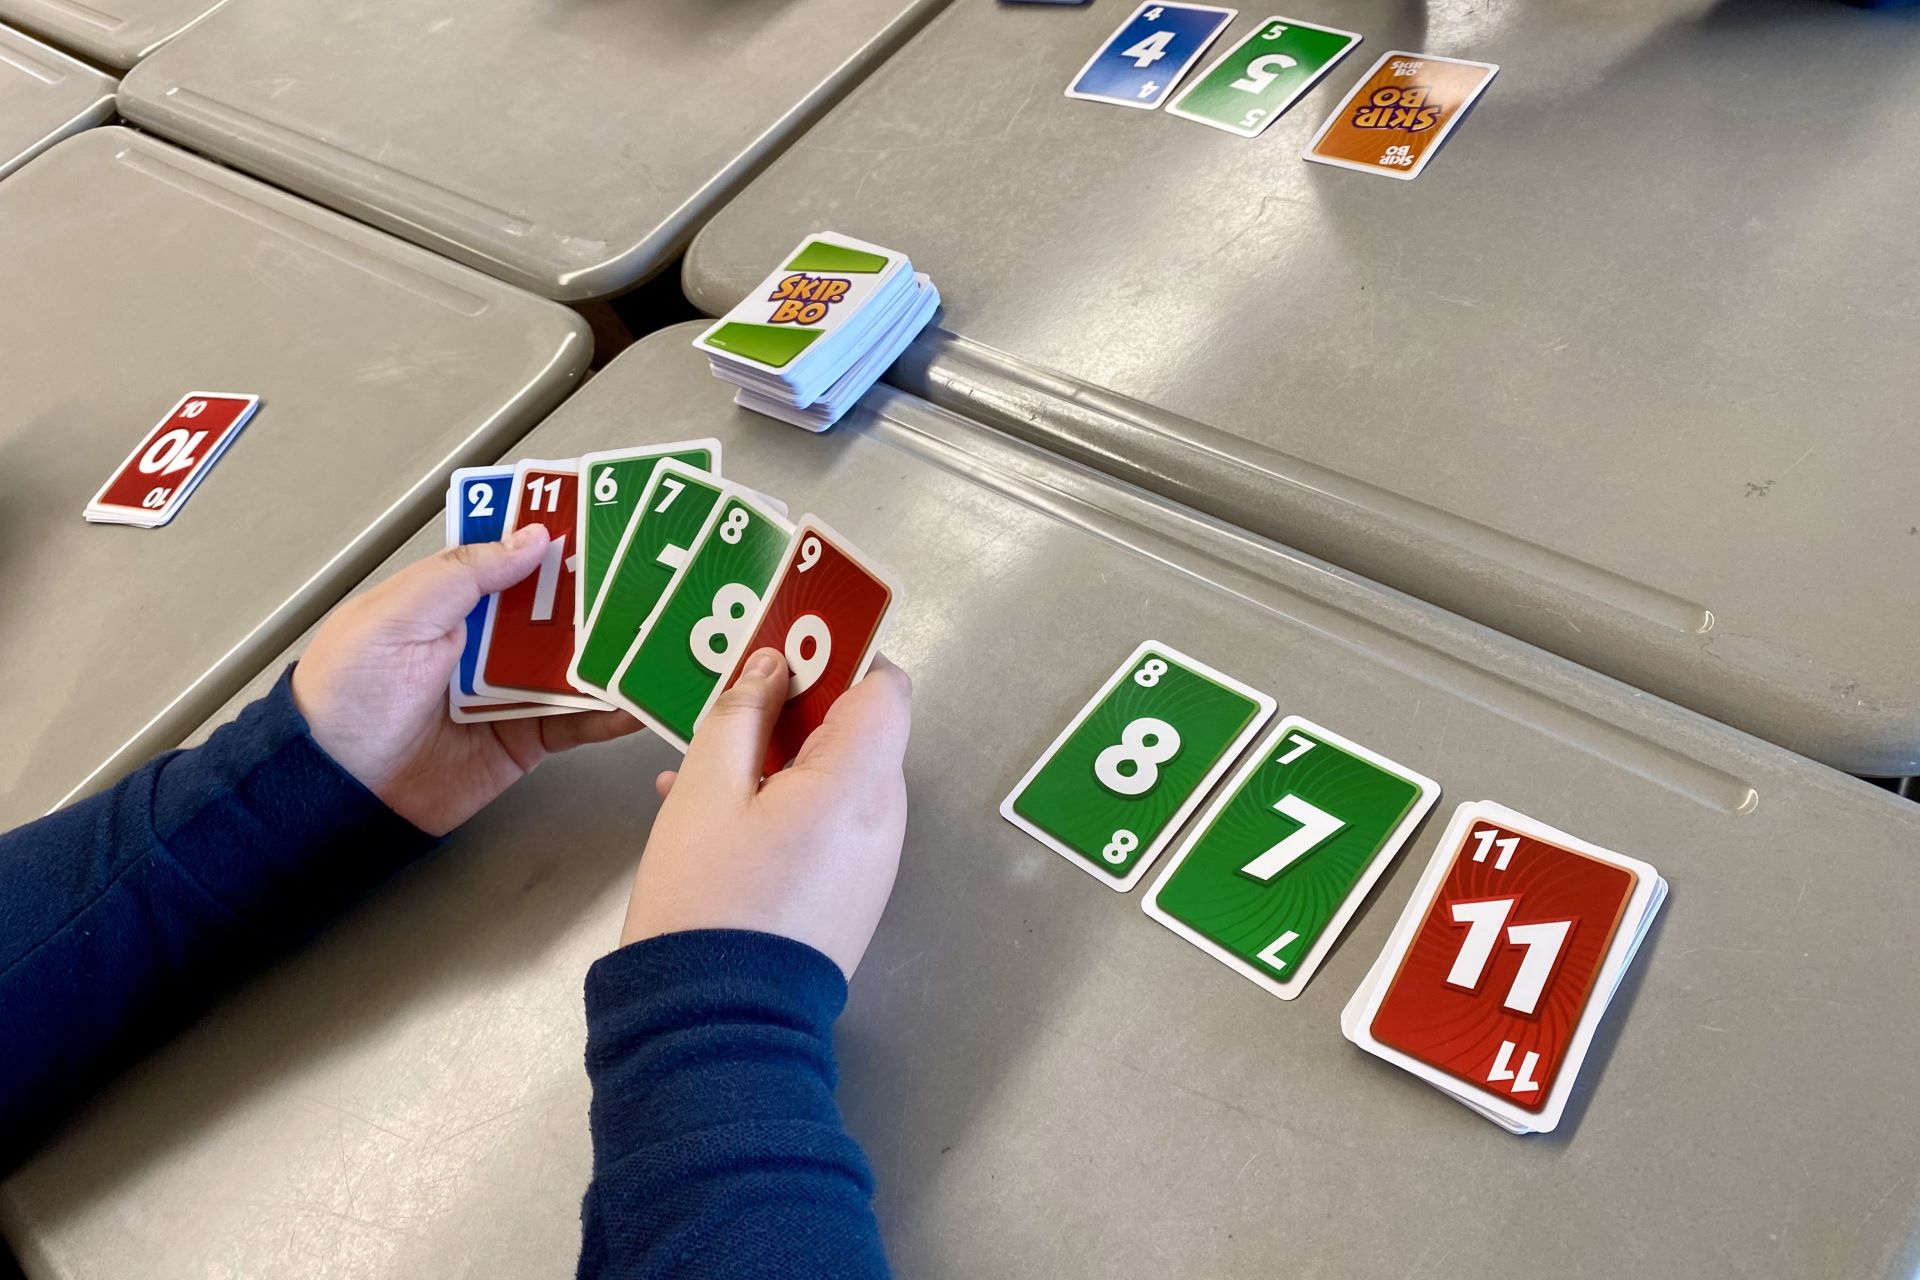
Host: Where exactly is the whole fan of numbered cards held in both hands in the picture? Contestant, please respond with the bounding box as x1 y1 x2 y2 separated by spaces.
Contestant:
447 439 899 773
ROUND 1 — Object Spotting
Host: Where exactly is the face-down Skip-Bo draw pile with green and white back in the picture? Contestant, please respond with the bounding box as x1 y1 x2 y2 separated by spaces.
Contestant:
693 232 941 441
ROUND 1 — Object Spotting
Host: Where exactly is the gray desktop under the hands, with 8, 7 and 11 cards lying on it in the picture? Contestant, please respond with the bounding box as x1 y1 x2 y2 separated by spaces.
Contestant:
4 326 1920 1280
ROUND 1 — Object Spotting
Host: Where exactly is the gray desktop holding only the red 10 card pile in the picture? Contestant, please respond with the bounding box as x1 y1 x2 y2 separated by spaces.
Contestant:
0 129 588 829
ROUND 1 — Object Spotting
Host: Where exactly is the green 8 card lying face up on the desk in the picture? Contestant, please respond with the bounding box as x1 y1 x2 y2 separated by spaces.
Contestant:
1000 641 1273 892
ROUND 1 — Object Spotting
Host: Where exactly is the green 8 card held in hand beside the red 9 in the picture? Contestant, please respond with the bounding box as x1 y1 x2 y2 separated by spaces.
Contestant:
607 482 793 750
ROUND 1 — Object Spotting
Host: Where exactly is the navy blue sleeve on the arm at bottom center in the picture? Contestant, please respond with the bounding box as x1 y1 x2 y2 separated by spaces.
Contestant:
580 929 887 1280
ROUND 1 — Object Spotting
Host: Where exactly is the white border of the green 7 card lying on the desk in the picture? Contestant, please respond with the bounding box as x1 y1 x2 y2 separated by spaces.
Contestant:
1140 716 1440 1000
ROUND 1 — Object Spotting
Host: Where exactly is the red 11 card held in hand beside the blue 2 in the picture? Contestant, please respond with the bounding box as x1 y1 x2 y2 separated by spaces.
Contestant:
474 459 607 710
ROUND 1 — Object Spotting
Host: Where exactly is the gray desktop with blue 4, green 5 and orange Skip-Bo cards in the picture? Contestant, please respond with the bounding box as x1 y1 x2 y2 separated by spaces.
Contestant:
685 0 1920 773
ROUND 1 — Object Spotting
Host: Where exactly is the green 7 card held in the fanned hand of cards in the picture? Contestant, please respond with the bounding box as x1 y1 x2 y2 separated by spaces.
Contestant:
566 459 726 697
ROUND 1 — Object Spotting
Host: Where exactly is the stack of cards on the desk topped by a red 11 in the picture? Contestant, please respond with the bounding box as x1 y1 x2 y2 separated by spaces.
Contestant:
1340 800 1667 1134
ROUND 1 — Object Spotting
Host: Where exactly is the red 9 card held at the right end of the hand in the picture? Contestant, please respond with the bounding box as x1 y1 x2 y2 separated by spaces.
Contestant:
695 516 899 773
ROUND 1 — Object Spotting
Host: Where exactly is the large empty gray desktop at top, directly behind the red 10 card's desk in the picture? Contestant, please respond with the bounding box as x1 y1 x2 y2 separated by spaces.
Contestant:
121 0 947 301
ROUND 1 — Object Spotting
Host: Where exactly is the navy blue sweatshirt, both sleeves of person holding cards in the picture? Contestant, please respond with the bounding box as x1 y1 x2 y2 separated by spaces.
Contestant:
0 676 887 1280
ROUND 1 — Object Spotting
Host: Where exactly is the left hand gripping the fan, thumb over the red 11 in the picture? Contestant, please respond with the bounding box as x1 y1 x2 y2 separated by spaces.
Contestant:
294 524 639 835
